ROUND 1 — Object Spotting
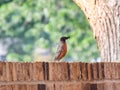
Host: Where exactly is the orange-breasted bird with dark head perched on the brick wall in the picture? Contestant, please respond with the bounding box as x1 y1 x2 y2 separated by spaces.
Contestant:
54 37 70 61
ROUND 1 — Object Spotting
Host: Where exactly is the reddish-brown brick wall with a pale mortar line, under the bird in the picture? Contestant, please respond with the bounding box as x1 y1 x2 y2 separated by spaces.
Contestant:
0 62 120 90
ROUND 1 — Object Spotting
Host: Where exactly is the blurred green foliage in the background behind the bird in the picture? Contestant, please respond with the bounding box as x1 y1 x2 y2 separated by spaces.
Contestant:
0 0 98 62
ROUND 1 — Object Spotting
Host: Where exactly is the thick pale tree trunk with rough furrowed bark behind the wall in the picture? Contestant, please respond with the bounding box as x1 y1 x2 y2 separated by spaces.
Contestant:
73 0 120 62
